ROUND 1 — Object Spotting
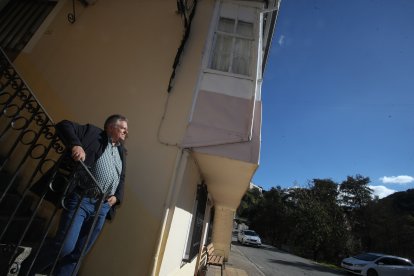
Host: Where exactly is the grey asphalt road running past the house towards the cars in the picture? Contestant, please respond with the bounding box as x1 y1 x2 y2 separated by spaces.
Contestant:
232 241 347 276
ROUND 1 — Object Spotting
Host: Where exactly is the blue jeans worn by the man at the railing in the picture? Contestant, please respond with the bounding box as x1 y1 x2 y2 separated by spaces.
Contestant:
40 194 111 276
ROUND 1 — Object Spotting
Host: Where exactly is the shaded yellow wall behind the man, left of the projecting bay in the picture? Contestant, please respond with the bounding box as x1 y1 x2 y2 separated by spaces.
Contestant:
15 0 213 276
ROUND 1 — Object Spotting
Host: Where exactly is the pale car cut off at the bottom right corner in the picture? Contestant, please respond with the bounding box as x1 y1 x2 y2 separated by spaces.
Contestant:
341 253 414 276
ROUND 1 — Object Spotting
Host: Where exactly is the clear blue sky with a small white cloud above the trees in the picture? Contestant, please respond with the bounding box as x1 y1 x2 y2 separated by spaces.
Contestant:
253 0 414 197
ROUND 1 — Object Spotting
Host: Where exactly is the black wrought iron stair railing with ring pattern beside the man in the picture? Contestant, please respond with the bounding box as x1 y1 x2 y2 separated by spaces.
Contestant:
0 49 106 275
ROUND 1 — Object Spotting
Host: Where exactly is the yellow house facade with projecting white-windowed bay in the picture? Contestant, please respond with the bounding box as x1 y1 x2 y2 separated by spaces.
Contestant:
0 0 279 276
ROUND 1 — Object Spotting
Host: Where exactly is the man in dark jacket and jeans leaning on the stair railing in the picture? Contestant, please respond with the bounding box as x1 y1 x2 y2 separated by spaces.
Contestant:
35 114 128 276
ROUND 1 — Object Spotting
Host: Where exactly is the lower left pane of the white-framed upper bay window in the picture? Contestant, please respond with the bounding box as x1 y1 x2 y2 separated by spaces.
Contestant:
211 34 232 72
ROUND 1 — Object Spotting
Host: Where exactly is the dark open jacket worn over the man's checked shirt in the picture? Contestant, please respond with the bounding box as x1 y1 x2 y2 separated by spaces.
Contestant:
32 120 126 219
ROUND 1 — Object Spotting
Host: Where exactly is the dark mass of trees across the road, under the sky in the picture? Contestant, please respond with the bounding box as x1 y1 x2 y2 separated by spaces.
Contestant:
238 175 414 263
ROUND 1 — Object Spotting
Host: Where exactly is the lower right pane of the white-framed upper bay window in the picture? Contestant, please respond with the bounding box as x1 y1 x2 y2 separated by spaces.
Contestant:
231 38 252 76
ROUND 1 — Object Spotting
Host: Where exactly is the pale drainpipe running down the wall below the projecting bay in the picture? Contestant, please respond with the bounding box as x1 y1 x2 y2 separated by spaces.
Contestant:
150 149 189 276
